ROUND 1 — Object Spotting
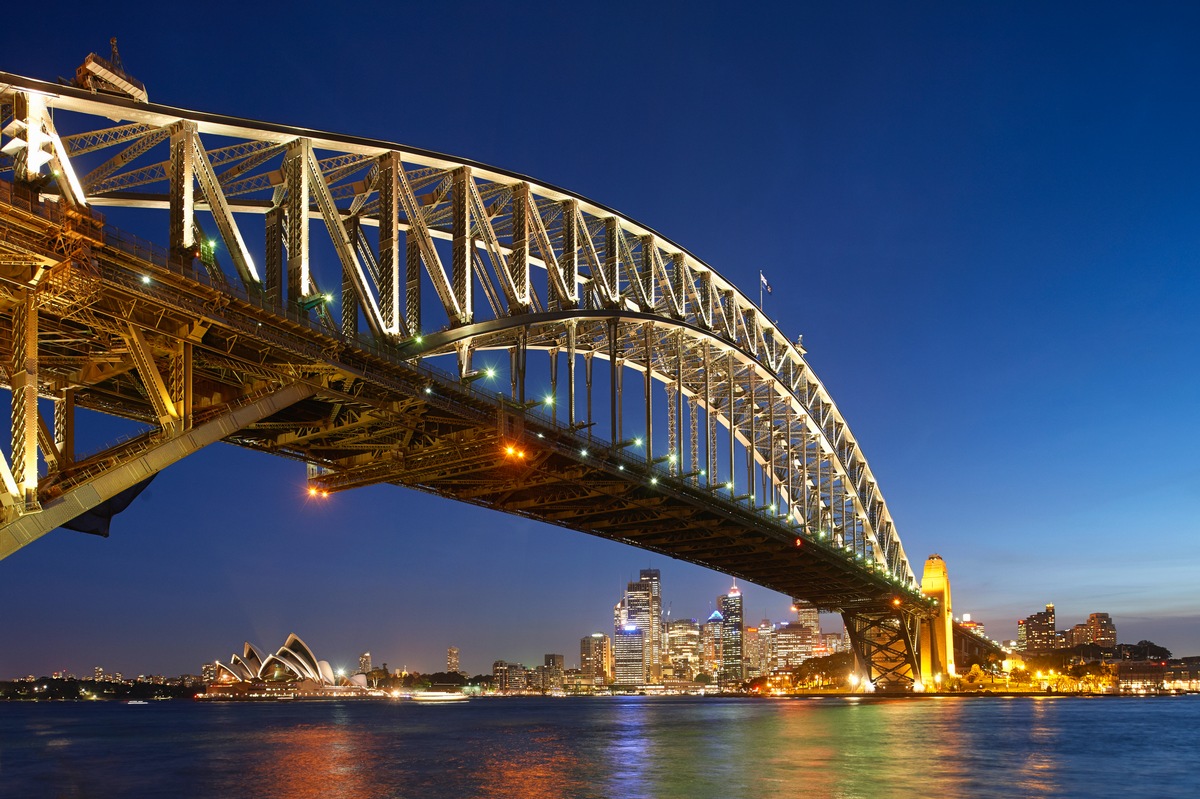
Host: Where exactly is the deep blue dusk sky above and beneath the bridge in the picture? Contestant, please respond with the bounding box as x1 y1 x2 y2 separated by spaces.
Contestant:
0 2 1200 678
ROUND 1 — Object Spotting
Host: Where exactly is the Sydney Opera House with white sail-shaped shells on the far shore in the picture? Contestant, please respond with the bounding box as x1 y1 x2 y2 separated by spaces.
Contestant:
198 633 374 699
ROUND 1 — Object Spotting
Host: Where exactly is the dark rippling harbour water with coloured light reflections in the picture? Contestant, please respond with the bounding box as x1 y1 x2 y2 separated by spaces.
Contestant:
0 696 1200 799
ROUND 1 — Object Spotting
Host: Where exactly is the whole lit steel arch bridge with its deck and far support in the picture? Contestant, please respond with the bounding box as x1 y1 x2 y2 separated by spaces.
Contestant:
0 55 980 689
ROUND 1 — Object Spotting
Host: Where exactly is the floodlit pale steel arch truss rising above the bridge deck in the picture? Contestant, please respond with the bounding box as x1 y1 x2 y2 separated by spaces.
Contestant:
0 68 917 676
